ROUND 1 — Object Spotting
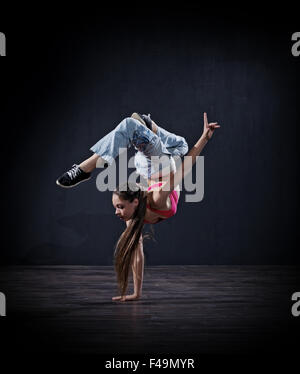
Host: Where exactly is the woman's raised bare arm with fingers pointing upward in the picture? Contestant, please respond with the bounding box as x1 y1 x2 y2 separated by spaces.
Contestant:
153 113 221 206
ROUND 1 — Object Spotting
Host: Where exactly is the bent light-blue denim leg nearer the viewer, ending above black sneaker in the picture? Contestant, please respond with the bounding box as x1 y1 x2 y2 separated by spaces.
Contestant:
90 117 163 165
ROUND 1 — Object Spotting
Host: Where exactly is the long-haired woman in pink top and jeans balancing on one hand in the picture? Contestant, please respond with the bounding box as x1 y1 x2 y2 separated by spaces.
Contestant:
56 113 220 301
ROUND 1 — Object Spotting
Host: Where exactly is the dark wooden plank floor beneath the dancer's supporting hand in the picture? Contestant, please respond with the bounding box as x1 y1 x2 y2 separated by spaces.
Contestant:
0 266 300 354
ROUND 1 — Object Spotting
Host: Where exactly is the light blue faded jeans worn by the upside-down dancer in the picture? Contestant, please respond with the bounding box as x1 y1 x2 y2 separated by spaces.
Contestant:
90 117 188 179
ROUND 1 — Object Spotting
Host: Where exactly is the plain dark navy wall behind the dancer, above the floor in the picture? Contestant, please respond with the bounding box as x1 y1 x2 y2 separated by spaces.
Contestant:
0 5 300 265
